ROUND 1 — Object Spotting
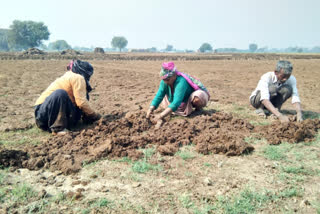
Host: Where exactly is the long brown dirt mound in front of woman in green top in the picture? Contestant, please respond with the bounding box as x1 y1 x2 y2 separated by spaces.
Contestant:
0 111 254 174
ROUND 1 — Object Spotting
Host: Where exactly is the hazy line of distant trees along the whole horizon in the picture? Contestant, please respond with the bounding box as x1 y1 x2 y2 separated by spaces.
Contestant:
0 20 320 53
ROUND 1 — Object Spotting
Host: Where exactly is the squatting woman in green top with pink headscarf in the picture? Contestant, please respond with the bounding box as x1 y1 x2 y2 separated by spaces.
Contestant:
147 62 210 128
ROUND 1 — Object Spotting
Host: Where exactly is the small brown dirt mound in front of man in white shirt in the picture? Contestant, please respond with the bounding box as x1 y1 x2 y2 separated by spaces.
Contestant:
259 119 320 145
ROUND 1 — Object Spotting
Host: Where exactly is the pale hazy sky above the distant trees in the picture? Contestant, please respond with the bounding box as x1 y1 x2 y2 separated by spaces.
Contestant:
0 0 320 49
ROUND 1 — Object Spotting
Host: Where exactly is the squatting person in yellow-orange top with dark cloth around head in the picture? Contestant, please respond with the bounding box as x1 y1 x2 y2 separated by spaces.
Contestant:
35 60 101 134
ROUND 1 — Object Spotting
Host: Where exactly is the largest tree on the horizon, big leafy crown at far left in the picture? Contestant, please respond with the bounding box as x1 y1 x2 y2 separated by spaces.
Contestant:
8 20 50 50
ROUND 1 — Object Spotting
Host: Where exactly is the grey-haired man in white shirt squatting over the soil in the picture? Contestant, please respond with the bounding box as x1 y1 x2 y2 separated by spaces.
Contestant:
250 60 303 122
